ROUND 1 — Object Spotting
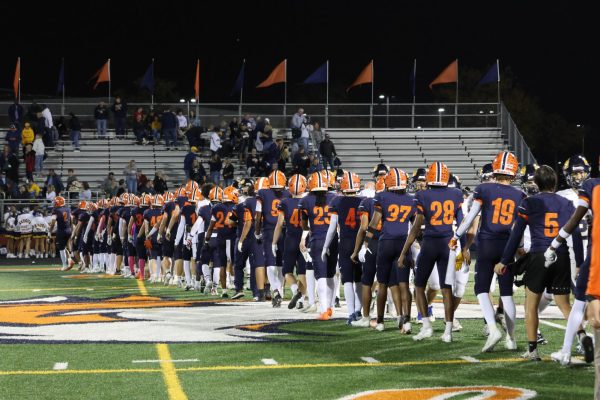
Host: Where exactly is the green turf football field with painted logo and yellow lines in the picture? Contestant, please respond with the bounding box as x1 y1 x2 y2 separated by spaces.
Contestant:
0 260 594 399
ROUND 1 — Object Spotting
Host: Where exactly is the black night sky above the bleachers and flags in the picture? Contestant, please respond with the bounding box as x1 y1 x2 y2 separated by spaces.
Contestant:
0 0 598 164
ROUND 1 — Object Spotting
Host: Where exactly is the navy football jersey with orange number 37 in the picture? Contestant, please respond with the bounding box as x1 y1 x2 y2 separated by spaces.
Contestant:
374 191 417 240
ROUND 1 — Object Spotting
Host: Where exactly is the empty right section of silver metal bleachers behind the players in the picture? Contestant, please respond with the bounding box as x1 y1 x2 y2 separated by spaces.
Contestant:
328 128 507 187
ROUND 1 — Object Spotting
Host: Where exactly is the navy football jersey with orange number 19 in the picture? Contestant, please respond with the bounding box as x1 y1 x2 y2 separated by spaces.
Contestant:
473 182 527 239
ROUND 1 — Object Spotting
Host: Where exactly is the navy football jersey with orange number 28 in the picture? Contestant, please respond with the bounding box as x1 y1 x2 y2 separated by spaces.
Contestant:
415 187 463 237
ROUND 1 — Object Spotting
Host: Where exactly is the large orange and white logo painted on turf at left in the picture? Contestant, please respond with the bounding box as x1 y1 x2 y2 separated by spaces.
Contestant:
0 296 316 343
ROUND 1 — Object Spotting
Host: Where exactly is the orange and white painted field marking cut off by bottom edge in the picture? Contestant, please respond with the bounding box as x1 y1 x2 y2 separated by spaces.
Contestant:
340 386 537 400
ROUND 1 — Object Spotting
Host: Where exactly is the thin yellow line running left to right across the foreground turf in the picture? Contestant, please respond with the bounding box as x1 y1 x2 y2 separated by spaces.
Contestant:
0 358 528 376
